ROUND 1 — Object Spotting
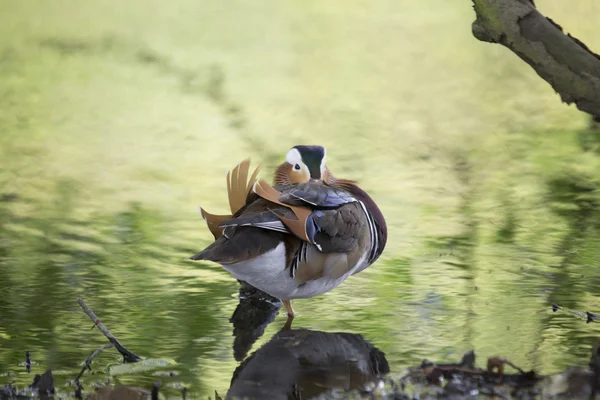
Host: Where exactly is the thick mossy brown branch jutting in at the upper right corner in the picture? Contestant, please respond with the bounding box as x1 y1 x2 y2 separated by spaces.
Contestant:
472 0 600 120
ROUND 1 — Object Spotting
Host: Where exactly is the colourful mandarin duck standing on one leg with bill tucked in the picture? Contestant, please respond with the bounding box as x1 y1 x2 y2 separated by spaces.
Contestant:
190 145 387 319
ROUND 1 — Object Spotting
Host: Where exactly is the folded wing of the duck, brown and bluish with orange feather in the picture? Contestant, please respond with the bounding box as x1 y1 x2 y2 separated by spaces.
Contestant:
192 181 370 283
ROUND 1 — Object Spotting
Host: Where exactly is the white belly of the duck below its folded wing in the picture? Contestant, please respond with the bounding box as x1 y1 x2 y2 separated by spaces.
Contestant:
223 243 365 300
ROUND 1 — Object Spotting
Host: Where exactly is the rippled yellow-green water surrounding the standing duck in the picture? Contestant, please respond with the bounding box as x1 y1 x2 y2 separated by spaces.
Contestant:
0 0 600 396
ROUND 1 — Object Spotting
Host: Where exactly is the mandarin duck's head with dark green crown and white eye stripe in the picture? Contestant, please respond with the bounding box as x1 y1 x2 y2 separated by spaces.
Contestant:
275 145 328 185
